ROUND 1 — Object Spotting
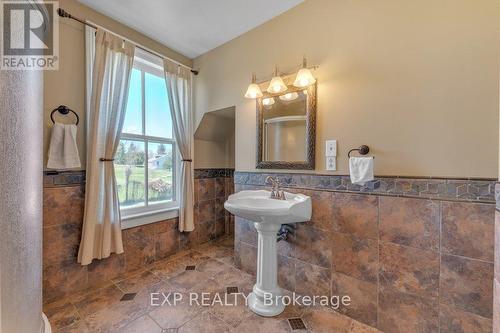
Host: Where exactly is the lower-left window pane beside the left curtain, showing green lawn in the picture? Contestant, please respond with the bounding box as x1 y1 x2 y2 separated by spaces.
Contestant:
115 140 145 208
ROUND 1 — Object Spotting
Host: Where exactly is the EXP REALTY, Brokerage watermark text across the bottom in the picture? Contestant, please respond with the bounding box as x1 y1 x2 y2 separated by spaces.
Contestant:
151 292 351 310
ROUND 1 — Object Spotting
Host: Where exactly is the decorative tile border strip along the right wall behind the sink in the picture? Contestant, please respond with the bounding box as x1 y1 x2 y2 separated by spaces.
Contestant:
234 171 500 202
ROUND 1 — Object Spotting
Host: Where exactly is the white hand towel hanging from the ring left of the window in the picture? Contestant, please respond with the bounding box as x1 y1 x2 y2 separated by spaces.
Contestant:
47 123 81 170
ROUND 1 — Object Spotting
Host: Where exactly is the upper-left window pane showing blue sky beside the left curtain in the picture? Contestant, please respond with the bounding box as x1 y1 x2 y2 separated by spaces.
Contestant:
122 68 142 134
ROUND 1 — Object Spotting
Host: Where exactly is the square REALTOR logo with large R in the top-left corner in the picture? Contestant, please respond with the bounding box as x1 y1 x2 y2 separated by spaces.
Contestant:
0 0 59 70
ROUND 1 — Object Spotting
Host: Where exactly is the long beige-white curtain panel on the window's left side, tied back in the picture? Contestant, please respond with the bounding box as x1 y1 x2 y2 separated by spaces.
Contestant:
78 29 135 265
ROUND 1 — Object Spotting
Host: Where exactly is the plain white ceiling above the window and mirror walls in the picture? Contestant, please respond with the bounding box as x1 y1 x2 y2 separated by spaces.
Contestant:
78 0 304 58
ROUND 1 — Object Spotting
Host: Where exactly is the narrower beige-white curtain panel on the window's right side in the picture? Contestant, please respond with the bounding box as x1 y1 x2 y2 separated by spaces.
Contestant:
163 59 194 231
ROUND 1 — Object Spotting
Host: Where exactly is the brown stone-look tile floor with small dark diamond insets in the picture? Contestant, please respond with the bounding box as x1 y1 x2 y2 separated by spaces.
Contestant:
44 239 378 333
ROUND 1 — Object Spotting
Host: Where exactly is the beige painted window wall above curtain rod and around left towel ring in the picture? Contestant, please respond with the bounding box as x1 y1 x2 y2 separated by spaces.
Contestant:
43 0 192 169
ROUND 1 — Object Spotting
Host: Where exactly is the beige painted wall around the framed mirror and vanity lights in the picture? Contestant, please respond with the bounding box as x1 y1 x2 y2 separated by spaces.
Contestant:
194 0 500 177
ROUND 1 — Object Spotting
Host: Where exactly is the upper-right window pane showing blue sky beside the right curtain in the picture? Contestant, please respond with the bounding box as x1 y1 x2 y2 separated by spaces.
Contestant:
144 73 172 138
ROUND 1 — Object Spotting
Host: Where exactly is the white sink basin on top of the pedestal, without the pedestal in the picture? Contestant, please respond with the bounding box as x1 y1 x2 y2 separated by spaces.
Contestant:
224 190 311 224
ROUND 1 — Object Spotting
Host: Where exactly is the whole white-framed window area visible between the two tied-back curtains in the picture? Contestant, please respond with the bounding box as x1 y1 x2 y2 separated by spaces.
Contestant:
114 54 179 218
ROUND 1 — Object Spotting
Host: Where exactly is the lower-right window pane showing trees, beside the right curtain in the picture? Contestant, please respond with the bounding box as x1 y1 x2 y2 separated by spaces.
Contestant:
148 142 174 203
